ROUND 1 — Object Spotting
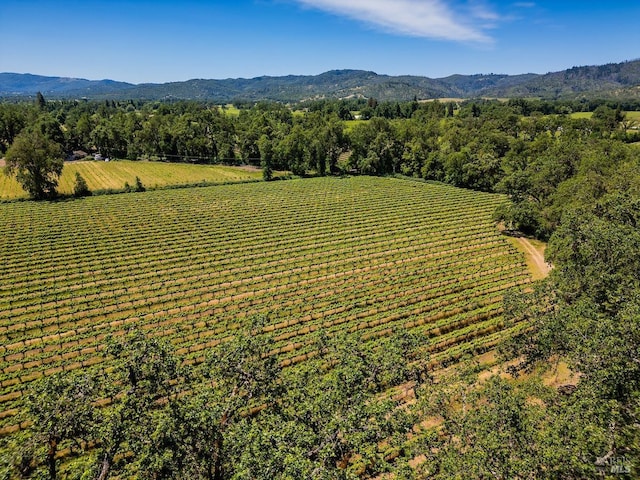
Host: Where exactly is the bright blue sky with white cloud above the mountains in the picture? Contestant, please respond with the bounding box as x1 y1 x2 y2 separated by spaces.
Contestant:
0 0 640 83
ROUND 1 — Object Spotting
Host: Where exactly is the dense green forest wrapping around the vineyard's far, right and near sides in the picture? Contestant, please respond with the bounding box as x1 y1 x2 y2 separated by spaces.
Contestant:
0 95 640 479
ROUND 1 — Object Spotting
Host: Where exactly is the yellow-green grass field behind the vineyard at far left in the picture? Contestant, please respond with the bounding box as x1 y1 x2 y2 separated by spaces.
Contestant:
0 160 266 200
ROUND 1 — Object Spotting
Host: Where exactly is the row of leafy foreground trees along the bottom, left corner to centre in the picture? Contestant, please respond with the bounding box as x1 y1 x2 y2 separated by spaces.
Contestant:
2 326 423 480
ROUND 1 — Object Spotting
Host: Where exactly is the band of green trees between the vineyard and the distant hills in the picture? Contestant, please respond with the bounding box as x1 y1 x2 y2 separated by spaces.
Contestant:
0 97 640 208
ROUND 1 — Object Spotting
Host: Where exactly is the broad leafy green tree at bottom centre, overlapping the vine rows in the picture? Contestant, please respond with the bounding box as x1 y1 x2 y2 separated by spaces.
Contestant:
260 335 417 480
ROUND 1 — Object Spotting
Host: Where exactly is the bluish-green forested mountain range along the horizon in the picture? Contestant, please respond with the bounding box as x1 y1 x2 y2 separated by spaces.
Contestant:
0 60 640 103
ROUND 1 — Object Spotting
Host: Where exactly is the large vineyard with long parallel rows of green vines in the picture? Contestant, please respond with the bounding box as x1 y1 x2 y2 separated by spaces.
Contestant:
0 177 530 434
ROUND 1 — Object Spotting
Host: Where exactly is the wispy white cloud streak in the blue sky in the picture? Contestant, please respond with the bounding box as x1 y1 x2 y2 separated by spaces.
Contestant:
294 0 499 43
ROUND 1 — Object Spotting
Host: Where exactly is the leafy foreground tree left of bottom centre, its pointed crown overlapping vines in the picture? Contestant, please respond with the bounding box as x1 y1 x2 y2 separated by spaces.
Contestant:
126 321 281 480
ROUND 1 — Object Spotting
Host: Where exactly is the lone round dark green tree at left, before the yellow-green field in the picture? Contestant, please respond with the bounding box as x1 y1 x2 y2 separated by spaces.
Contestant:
5 130 64 200
